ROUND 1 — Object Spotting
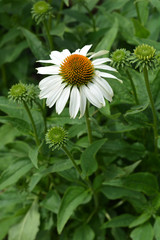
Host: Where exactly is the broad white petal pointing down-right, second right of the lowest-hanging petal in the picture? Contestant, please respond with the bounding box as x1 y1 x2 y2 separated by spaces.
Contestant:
83 83 105 108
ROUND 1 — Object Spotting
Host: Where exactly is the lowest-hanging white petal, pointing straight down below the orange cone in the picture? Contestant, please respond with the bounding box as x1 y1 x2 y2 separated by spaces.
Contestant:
69 86 80 118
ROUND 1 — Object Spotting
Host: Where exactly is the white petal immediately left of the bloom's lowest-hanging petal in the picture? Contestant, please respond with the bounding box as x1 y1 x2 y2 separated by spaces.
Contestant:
56 86 71 114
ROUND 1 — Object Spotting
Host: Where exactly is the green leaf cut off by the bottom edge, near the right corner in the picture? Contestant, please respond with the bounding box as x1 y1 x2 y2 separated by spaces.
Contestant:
130 223 154 240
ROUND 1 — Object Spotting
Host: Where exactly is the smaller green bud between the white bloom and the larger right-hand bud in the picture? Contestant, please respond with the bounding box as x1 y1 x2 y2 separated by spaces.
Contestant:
110 48 131 69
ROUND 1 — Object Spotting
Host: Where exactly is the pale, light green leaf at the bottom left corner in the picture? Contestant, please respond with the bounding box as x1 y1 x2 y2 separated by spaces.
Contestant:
8 202 40 240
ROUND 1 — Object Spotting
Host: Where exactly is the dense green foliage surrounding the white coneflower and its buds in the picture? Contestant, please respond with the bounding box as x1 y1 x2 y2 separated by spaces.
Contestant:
0 0 160 240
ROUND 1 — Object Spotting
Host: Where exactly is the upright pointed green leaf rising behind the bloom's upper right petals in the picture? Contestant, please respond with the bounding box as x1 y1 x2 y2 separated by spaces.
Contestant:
95 19 118 52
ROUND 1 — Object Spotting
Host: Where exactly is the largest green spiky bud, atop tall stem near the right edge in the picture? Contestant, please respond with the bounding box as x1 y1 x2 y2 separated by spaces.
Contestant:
130 44 158 72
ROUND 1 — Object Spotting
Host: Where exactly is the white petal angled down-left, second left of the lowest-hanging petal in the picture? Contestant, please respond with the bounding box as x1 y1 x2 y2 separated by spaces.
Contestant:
46 83 66 108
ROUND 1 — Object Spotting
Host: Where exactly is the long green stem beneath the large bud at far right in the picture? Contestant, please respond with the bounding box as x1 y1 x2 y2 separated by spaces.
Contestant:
143 67 158 153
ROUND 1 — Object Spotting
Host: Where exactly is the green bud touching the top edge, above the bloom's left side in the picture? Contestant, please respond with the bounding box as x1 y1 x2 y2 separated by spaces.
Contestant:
31 1 52 24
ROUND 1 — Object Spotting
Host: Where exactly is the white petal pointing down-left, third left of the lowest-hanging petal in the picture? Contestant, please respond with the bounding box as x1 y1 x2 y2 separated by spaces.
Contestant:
39 81 61 99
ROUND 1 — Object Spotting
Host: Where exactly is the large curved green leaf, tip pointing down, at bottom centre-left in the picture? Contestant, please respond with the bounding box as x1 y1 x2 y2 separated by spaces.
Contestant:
57 186 90 234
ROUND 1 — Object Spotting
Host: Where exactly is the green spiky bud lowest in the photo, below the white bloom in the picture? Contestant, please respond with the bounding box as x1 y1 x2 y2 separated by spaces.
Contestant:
46 127 68 150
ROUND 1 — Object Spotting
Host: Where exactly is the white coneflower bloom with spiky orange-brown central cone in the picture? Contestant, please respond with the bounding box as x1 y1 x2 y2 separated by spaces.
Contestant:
37 45 121 118
